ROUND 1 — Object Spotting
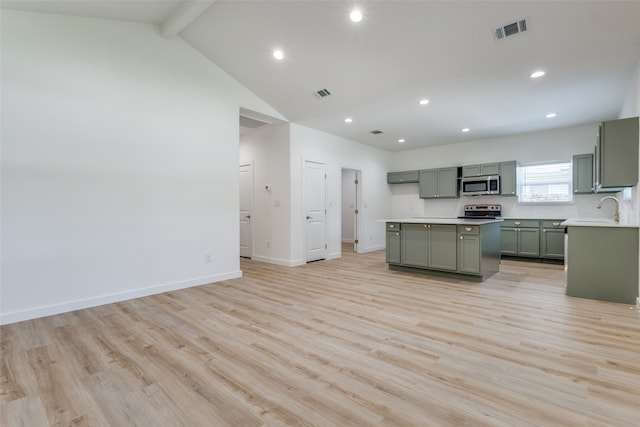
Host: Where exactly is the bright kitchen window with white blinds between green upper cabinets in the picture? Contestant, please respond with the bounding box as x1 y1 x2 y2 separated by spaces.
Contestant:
518 162 573 203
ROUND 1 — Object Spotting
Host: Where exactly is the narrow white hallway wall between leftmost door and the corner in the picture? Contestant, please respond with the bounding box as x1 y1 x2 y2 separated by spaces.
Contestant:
240 124 291 265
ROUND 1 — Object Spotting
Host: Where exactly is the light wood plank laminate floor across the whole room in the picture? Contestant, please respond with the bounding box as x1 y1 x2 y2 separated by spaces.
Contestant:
0 250 640 427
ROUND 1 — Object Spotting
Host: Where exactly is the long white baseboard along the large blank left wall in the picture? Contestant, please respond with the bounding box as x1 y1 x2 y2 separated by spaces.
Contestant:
0 271 242 325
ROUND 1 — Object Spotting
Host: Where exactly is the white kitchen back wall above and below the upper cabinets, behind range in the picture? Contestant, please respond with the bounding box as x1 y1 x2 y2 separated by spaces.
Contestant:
390 124 624 219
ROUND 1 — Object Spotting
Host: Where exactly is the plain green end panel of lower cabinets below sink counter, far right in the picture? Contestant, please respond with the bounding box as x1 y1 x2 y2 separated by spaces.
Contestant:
566 225 639 305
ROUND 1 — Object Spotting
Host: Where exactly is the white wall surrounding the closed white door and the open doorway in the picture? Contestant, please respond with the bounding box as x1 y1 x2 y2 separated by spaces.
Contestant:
291 124 391 262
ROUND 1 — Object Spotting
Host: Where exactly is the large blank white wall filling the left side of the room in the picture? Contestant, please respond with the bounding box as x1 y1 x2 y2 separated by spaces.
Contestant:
0 9 278 323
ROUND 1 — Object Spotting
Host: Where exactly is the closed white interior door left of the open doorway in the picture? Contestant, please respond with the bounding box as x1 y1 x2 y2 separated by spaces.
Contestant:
302 161 327 262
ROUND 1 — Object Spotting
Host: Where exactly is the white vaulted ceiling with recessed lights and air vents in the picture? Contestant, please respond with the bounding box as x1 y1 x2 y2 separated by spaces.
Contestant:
2 0 640 151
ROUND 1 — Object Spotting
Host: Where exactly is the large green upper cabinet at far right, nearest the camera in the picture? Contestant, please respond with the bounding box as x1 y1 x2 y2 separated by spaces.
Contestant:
595 117 639 191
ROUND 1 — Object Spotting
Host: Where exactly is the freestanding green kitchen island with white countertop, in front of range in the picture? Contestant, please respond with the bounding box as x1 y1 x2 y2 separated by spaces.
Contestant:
384 217 502 281
